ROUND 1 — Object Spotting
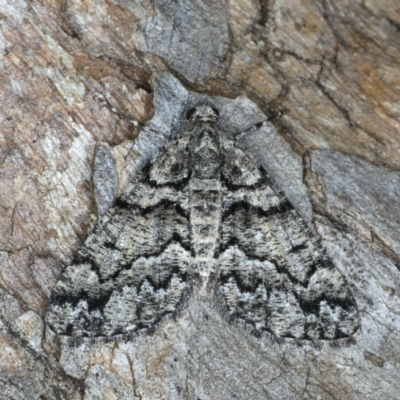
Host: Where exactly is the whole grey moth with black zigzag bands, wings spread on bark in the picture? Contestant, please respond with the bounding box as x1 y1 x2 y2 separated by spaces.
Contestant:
47 105 360 341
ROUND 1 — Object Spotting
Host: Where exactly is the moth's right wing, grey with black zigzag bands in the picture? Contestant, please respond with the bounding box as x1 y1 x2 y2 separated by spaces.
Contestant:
216 140 359 340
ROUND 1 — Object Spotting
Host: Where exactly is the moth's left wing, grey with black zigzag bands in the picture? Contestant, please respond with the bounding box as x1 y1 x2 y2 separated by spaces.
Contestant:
47 137 192 340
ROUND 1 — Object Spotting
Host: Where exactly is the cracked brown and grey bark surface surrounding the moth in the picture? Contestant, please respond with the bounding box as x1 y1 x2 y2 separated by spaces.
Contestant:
0 0 400 399
